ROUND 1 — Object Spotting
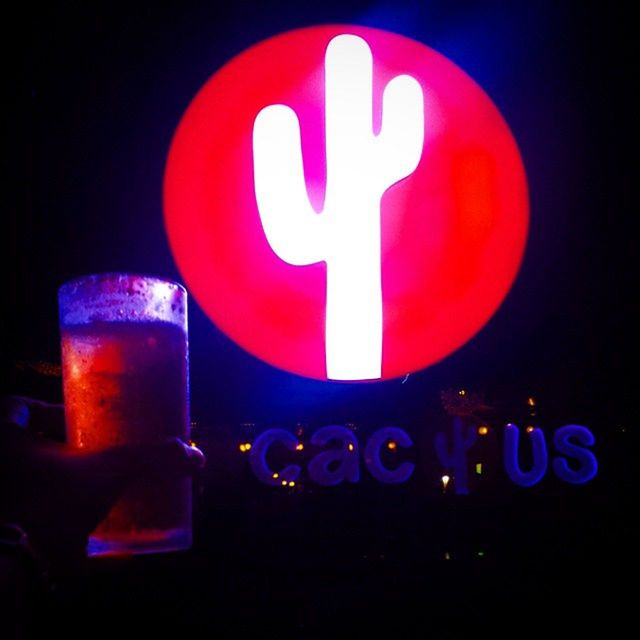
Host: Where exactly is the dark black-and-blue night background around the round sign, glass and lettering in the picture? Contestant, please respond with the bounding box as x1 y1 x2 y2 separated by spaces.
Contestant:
0 0 637 638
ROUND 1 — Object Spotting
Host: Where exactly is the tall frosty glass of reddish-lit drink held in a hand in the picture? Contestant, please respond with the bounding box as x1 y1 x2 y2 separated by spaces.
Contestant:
58 273 191 555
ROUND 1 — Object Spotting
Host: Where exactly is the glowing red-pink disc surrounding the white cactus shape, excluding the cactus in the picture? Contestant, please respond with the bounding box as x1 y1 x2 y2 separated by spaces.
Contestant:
164 26 528 379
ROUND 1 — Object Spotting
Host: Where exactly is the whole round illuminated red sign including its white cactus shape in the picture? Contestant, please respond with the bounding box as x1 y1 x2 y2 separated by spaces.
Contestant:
164 25 528 381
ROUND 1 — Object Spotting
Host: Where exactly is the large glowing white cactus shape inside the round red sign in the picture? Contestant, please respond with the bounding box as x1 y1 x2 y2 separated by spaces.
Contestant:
253 34 424 380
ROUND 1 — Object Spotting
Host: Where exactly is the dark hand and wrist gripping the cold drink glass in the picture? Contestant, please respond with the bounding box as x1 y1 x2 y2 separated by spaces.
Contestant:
0 397 205 569
